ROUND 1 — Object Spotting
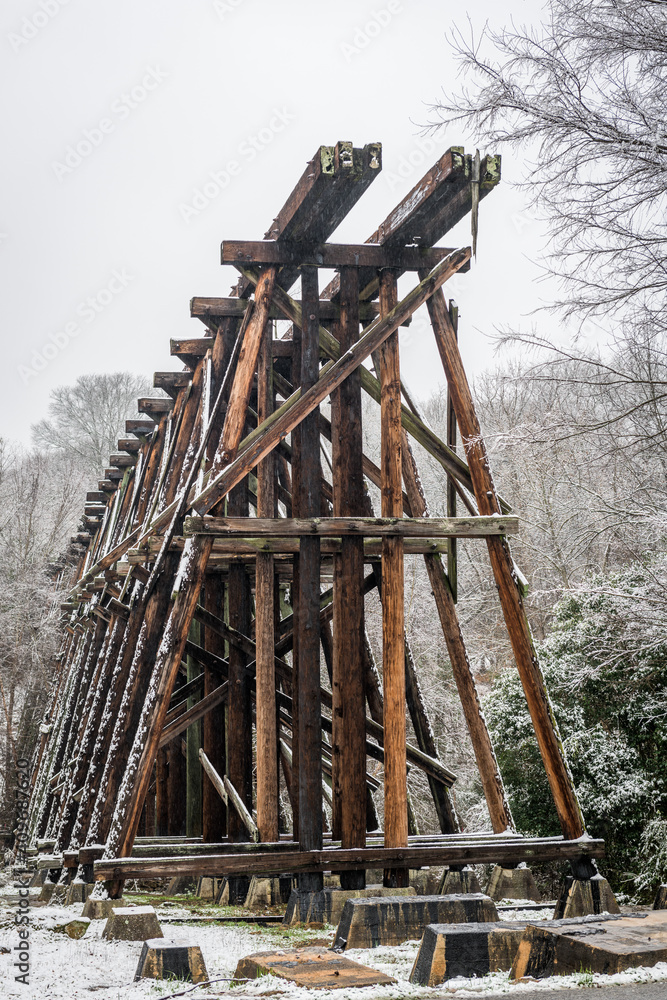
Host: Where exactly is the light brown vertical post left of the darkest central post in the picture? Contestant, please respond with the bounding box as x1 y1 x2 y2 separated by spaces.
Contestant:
255 323 280 843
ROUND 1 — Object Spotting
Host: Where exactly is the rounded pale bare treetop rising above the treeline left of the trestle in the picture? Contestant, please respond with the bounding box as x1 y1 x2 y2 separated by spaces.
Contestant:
32 372 151 477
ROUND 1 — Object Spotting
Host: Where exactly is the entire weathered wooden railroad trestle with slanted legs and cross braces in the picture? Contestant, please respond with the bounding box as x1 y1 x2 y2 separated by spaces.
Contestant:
30 142 604 894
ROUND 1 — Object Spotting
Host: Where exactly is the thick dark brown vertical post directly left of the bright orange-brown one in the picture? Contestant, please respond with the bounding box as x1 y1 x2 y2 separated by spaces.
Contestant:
331 267 366 889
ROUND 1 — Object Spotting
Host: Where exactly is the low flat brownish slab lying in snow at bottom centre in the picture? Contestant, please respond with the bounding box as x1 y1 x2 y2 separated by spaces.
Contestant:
234 948 396 990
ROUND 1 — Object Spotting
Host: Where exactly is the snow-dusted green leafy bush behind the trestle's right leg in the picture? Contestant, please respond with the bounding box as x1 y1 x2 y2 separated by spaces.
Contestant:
485 560 667 901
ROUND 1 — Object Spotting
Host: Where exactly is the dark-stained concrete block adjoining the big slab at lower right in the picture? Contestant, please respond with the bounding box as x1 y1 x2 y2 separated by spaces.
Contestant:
410 921 526 986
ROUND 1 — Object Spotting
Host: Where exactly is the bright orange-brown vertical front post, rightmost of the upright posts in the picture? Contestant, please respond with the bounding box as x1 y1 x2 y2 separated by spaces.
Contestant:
379 270 409 887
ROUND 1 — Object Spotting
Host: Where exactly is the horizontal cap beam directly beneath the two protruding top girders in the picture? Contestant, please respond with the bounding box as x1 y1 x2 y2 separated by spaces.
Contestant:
220 239 453 271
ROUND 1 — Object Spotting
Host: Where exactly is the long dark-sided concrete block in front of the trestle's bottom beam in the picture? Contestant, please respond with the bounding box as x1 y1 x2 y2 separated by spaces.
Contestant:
334 893 498 951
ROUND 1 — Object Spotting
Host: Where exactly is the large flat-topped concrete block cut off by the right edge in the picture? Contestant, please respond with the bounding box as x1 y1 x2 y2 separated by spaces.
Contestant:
510 910 667 980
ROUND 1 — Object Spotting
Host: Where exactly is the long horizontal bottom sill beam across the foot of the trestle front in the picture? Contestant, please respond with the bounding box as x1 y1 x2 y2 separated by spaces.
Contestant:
94 837 604 881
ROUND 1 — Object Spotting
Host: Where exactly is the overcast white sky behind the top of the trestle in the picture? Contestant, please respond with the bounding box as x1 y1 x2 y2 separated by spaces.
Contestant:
0 0 549 443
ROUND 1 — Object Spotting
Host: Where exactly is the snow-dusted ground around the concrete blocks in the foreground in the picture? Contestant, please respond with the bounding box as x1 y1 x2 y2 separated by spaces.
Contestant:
0 897 667 1000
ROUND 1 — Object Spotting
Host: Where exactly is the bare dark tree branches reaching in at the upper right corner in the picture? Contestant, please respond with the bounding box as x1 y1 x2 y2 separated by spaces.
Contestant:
430 0 667 328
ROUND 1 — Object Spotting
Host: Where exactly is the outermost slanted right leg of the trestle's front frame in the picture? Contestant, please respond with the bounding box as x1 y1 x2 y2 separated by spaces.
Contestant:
428 282 585 852
